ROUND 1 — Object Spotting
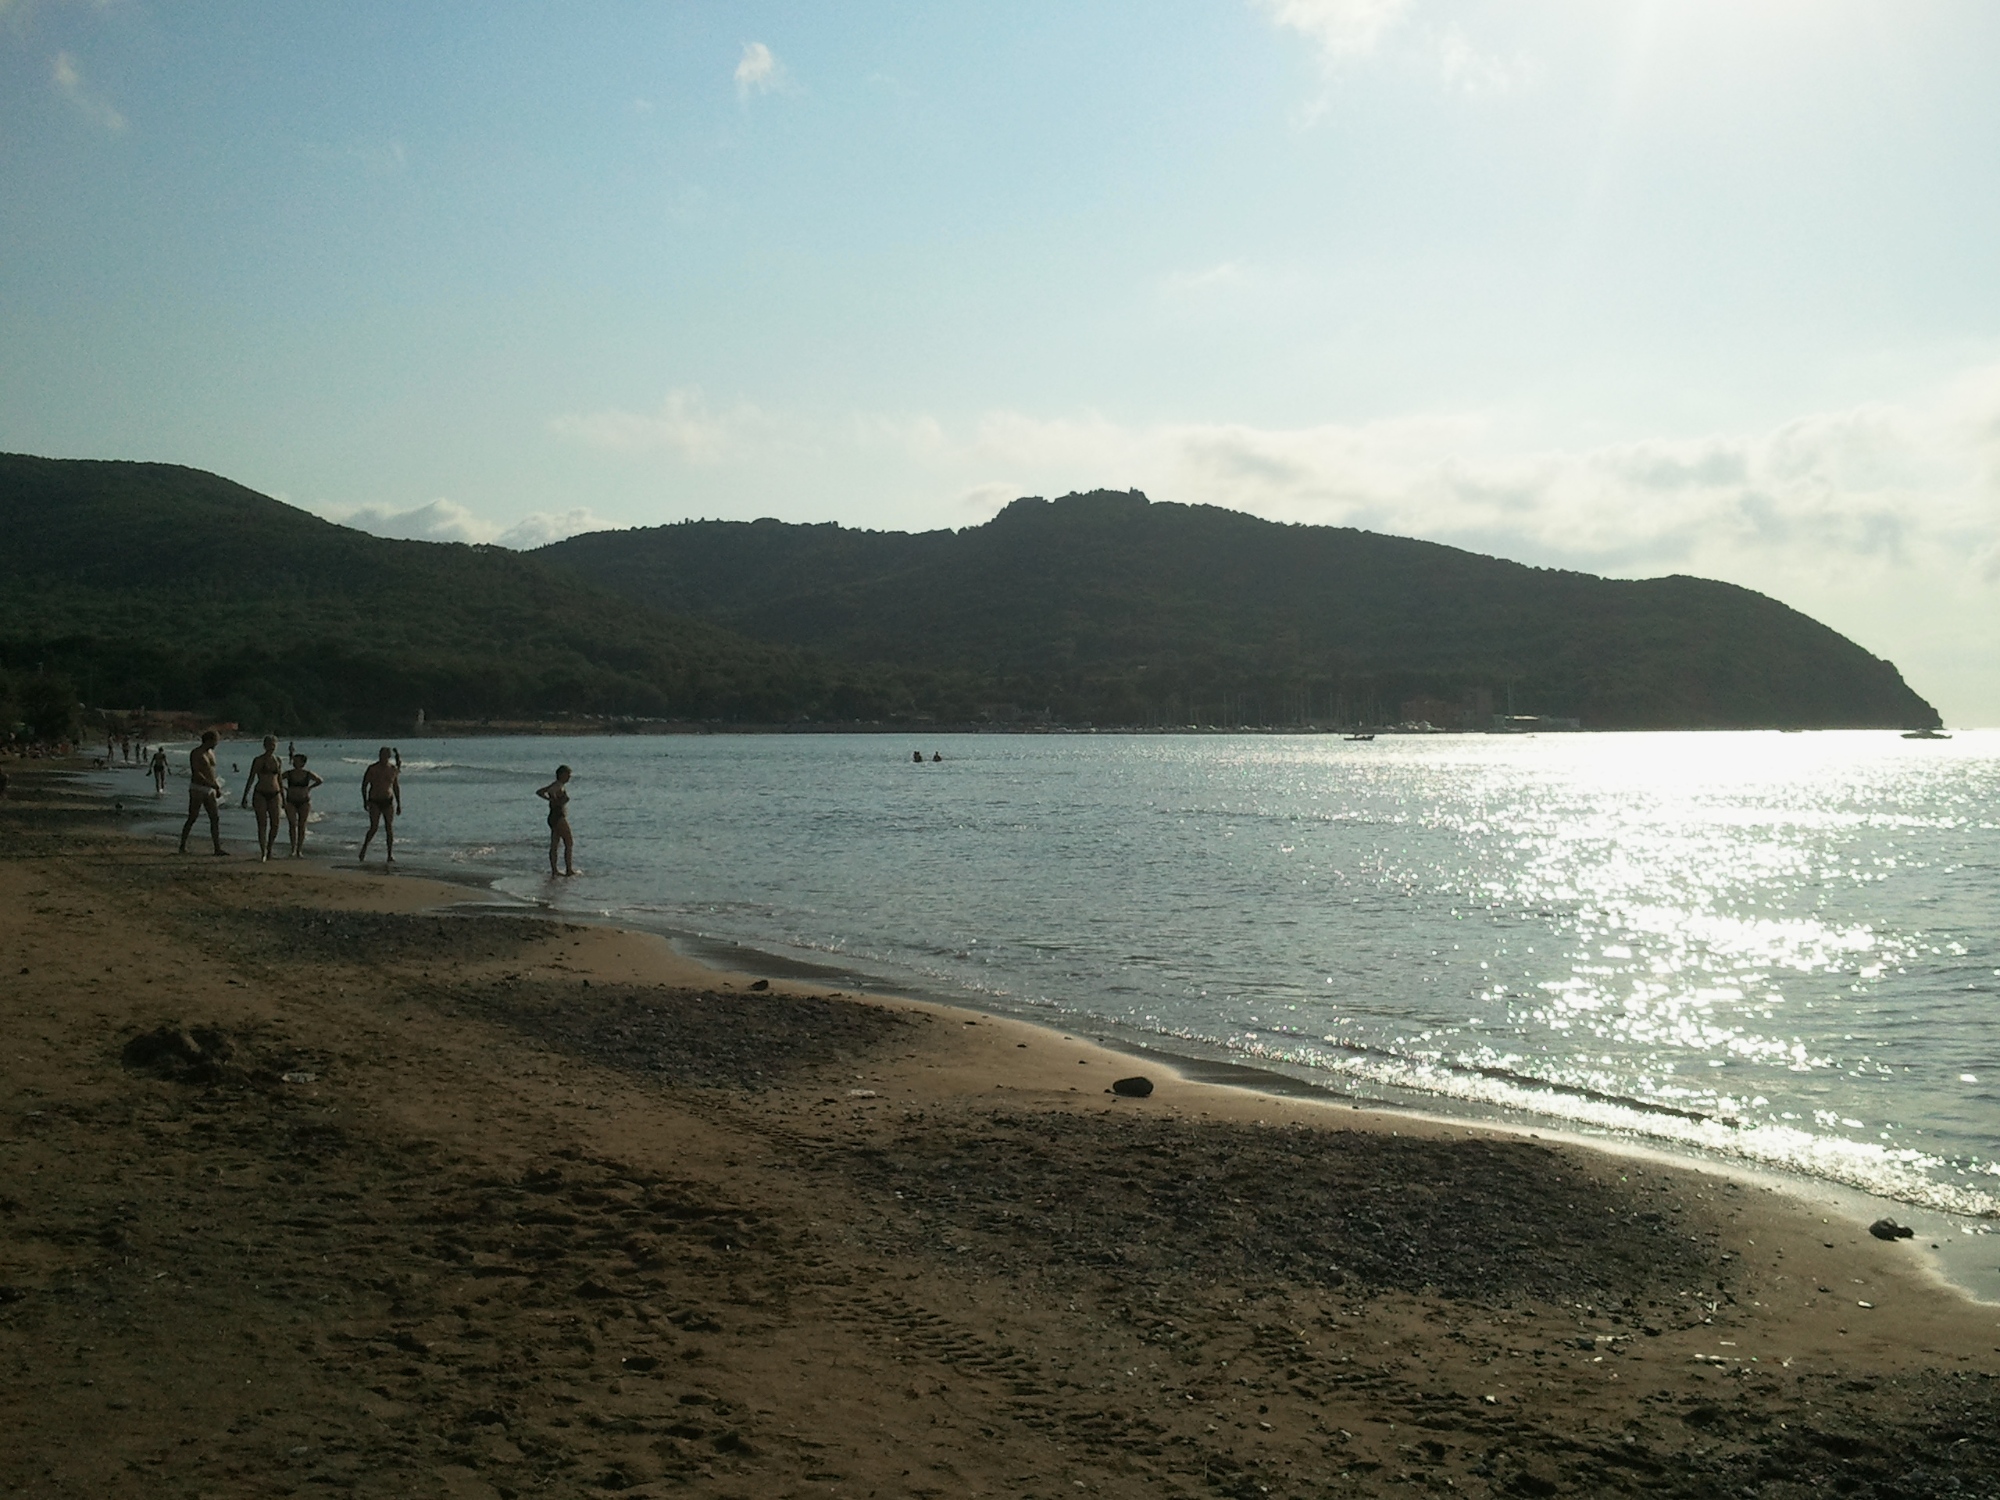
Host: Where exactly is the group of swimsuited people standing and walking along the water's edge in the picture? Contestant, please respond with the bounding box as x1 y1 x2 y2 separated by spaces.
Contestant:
168 730 576 876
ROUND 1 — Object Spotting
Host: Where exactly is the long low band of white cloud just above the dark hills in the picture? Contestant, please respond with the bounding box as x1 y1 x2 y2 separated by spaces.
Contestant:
550 366 2000 592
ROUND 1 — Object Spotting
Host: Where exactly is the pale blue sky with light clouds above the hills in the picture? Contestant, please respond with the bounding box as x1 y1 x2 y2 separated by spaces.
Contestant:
0 0 2000 726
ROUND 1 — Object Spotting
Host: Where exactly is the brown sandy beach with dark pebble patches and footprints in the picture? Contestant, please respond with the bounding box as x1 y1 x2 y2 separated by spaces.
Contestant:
0 774 2000 1498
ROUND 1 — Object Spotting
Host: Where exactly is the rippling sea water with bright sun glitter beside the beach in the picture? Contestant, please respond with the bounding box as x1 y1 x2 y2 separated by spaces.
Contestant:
129 732 2000 1216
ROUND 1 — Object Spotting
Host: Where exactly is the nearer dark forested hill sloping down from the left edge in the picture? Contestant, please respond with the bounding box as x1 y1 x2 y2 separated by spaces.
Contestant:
0 456 912 734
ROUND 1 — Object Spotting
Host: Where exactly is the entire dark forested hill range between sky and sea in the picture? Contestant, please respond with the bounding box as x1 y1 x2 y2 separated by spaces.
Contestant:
0 454 1938 732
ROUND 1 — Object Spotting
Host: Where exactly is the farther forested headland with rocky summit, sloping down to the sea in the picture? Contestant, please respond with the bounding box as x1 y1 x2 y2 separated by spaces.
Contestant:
534 490 1938 728
